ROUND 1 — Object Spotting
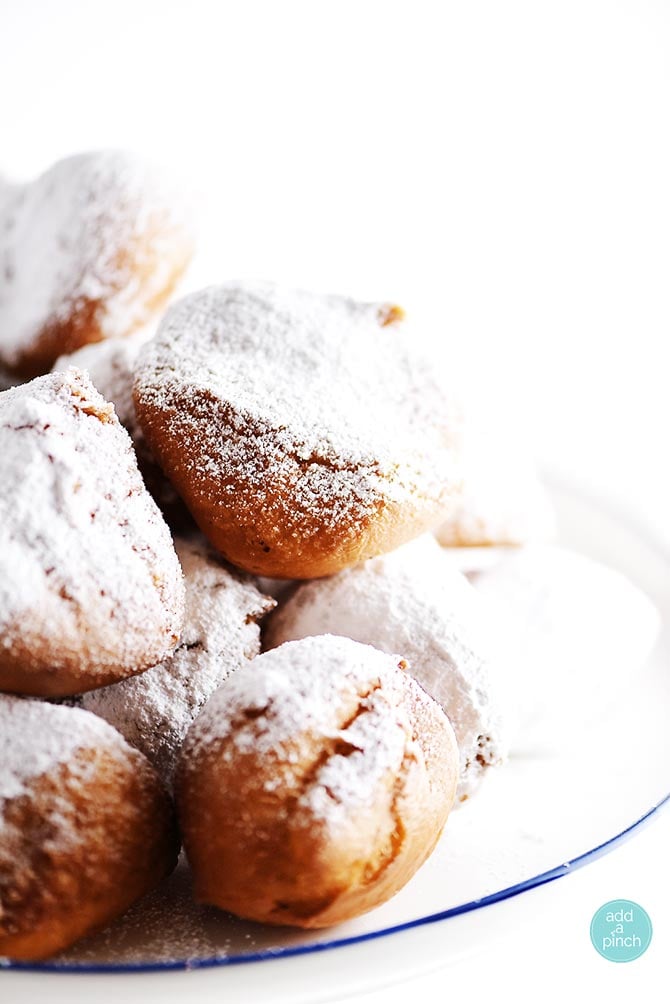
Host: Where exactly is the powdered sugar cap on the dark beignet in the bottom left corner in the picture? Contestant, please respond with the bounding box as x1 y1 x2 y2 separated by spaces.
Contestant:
0 694 129 803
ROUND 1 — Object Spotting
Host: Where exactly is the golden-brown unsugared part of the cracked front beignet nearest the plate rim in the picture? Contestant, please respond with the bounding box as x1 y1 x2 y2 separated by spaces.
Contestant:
176 640 458 928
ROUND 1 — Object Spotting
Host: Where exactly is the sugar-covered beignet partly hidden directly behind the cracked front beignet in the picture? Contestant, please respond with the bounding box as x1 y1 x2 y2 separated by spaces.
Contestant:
266 536 506 799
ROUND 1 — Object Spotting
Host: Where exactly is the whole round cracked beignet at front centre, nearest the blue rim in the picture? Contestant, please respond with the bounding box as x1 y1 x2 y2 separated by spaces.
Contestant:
176 635 458 928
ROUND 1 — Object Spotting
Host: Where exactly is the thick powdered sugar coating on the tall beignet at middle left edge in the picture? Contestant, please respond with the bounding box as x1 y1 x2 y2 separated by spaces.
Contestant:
0 369 184 689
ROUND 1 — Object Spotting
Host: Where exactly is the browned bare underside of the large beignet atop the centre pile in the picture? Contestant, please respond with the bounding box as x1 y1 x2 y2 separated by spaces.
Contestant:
135 388 448 579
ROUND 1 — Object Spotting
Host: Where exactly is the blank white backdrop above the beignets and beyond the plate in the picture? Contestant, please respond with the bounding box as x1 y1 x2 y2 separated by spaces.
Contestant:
0 0 670 1002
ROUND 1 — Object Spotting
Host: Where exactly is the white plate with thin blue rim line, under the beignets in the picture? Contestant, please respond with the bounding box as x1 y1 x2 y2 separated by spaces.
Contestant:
1 484 670 1004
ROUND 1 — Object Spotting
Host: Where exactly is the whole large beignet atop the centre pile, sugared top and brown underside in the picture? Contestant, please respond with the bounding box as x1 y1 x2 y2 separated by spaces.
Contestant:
135 283 460 577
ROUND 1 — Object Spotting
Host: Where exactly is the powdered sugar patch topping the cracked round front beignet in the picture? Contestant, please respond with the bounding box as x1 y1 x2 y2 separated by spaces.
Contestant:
182 635 448 829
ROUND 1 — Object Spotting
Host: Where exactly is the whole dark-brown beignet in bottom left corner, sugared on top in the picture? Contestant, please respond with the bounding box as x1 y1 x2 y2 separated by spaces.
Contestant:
0 696 179 960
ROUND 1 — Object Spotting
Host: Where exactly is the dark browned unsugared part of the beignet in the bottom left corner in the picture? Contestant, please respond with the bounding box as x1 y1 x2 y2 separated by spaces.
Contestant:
0 746 180 961
